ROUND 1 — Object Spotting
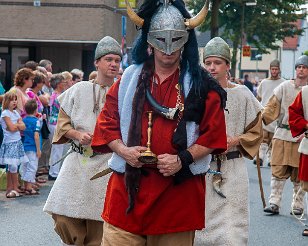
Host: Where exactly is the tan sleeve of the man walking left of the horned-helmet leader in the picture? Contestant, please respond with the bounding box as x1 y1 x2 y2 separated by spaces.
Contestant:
52 108 73 144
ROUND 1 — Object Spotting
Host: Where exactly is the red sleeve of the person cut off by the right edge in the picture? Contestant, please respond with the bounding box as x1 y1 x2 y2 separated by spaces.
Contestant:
289 92 308 137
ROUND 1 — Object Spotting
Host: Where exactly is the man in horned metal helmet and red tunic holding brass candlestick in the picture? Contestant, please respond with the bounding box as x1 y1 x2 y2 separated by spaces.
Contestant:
92 0 226 246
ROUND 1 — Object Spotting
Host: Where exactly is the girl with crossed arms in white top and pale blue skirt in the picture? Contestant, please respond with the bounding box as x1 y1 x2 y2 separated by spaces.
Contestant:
0 91 29 198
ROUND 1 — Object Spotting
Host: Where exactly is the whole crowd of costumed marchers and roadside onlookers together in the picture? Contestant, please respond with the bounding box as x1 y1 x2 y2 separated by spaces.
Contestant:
0 0 308 246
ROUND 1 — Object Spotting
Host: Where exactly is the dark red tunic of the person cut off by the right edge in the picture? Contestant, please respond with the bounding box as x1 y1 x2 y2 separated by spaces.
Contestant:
289 92 308 181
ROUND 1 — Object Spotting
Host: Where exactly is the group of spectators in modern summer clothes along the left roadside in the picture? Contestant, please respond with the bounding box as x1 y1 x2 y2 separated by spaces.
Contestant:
0 59 107 198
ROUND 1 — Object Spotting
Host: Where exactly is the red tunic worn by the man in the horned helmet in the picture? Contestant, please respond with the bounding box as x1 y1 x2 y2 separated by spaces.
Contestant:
92 71 226 235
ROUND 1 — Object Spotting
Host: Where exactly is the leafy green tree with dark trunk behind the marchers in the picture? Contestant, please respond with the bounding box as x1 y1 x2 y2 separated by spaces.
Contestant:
187 0 305 75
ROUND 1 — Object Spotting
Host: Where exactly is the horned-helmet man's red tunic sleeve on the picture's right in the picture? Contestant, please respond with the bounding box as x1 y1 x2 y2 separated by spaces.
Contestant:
196 91 227 154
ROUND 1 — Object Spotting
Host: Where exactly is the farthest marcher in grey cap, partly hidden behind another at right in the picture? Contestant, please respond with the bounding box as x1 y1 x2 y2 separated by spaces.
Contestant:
254 59 284 166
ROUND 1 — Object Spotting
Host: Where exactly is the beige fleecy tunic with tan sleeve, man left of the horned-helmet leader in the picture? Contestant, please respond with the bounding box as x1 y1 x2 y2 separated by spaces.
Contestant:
44 81 110 221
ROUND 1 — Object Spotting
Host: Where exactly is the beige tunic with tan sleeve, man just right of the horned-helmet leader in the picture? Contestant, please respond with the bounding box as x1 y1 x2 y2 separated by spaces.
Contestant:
202 85 263 246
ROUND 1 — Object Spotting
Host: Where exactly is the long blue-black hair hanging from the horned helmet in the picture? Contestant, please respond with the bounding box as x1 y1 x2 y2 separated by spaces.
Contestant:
132 0 226 107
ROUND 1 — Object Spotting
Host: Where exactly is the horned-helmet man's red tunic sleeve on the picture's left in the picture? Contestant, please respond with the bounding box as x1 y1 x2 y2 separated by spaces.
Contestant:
92 82 122 153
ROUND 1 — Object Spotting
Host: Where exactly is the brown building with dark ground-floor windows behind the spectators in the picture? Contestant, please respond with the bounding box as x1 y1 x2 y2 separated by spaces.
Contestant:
0 0 136 89
